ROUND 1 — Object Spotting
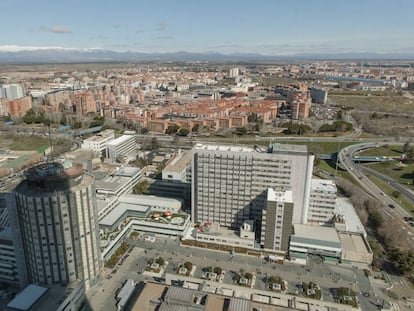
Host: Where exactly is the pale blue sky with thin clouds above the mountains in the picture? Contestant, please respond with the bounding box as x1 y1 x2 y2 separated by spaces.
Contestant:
0 0 414 55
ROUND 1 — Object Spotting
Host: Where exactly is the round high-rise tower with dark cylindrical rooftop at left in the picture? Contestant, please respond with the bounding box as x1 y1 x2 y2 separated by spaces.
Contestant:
11 162 102 290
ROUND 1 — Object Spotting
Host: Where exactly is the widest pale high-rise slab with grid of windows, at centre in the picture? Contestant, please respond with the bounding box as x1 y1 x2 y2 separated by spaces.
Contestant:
191 144 314 228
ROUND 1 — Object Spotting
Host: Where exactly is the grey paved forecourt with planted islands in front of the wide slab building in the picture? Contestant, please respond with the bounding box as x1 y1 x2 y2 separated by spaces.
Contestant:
88 237 400 311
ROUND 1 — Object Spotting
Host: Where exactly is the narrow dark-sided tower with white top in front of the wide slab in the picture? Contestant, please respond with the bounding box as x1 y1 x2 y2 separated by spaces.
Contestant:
260 189 294 252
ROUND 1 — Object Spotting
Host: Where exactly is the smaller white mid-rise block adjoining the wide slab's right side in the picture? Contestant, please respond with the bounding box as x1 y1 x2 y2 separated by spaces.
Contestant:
308 179 337 225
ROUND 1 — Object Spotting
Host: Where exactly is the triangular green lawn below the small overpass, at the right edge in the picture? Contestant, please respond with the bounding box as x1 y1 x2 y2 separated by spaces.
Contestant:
364 160 414 189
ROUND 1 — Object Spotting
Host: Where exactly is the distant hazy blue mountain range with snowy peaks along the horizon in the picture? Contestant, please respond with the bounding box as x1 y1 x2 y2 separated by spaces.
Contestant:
0 48 414 64
